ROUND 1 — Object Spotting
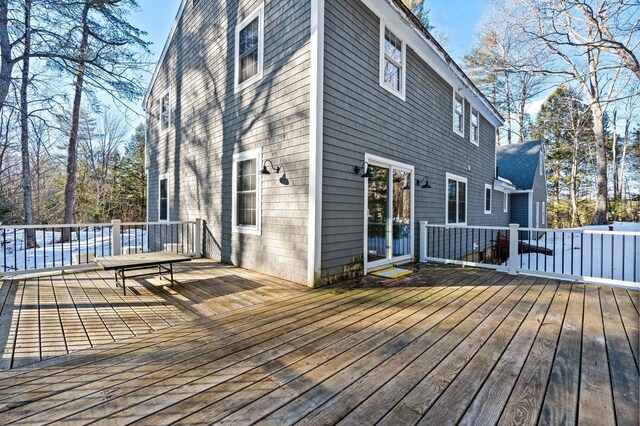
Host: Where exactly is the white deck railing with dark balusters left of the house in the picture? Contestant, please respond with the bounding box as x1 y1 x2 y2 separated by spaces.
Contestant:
0 219 202 276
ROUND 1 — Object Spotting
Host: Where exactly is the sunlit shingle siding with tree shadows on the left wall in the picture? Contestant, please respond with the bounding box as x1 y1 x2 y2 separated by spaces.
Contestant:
146 0 310 282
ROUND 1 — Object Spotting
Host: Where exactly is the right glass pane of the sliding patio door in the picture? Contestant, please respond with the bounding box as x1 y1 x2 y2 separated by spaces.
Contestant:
392 169 411 257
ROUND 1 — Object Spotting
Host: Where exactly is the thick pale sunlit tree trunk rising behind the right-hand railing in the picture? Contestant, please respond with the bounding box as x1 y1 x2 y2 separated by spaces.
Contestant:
591 103 609 225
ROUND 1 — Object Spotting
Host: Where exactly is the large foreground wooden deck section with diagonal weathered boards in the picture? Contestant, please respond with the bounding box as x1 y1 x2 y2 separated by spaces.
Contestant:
0 267 640 426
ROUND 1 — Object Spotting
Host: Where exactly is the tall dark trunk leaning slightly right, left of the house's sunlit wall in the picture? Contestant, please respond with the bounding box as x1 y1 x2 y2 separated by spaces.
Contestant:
62 2 90 242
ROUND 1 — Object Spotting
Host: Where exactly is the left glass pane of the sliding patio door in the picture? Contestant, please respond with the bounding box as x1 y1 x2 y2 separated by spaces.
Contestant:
367 165 389 262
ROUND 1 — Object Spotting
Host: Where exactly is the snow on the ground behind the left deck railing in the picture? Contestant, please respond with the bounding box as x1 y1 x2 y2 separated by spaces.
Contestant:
0 226 148 273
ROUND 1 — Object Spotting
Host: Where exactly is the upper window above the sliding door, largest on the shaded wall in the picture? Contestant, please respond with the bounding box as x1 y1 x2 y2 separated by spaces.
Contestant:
380 23 406 100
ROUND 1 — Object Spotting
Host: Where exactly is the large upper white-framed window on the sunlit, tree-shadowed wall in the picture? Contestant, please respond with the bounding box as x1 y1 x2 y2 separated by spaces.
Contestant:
235 4 264 90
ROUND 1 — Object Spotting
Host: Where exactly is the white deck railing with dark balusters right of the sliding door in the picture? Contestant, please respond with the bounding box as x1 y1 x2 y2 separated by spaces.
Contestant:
420 222 640 287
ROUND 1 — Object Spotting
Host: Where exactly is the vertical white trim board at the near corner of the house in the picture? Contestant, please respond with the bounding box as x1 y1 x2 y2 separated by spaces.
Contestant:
307 0 324 286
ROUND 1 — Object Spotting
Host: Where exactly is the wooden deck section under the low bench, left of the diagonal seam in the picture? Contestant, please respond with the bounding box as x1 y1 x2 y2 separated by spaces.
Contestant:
0 260 306 370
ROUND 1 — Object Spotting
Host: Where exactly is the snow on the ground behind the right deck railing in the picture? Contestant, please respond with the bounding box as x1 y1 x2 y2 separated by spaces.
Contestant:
518 222 640 282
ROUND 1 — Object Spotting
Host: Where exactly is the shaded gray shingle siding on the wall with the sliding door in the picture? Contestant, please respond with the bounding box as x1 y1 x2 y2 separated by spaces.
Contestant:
322 0 508 281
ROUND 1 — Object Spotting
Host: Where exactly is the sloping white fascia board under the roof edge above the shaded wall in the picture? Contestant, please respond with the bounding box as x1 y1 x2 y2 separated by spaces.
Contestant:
362 0 504 127
